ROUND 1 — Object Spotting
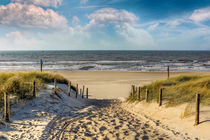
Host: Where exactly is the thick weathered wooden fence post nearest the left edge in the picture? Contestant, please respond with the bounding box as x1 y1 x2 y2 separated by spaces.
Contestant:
4 92 10 122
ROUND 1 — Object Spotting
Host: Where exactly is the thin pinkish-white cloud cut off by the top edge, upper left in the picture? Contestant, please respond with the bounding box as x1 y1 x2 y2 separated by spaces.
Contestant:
11 0 63 8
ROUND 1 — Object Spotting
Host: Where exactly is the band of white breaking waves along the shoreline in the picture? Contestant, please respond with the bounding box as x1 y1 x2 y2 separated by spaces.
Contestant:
0 60 210 71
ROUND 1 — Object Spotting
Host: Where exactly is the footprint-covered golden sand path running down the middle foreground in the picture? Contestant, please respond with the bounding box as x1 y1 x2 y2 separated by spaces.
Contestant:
42 101 174 140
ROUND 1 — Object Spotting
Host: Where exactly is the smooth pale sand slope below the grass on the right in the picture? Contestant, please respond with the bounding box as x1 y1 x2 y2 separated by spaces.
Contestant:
122 101 210 140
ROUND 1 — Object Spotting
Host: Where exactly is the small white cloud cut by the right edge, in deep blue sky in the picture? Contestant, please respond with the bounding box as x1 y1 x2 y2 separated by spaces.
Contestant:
190 7 210 22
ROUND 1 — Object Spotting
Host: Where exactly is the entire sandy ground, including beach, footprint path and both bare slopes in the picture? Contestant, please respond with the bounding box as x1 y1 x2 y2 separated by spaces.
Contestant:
0 71 210 140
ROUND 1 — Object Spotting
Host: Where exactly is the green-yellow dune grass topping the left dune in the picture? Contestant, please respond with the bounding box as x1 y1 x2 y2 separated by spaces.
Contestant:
0 71 68 106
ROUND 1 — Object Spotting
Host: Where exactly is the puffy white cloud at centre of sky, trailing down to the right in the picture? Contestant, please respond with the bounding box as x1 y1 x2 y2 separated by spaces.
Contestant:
86 8 153 49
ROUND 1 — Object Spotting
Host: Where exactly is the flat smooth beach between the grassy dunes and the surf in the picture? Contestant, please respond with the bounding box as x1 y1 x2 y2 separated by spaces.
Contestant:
56 71 210 99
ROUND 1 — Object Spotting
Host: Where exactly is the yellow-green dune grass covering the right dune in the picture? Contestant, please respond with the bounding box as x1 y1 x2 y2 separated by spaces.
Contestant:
127 75 210 106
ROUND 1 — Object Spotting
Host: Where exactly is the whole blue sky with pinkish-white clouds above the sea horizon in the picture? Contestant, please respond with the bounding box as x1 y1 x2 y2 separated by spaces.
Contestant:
0 0 210 50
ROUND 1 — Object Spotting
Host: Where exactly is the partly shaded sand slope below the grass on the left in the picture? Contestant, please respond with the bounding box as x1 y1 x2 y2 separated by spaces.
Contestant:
0 85 86 140
